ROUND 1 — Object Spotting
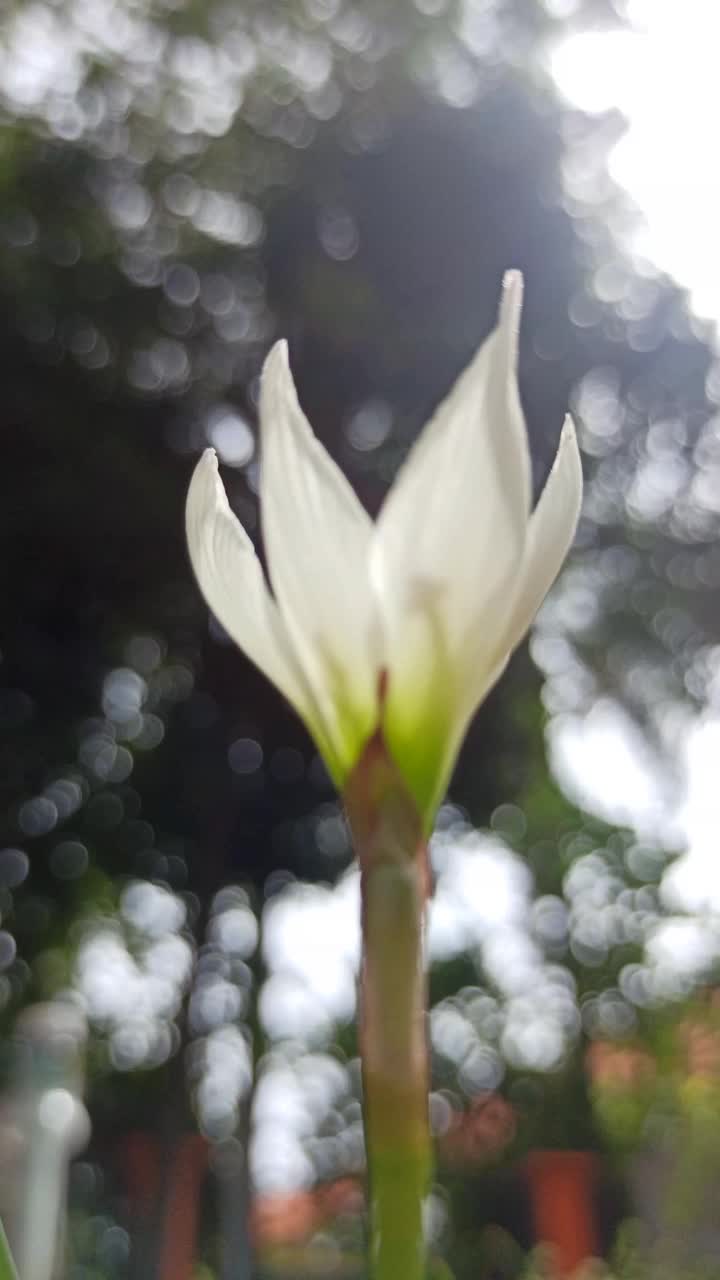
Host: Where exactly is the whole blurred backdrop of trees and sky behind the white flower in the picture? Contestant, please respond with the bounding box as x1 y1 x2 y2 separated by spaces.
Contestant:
0 0 720 1280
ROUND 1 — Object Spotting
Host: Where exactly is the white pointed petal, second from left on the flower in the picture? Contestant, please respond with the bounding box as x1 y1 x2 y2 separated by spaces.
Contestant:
260 342 379 769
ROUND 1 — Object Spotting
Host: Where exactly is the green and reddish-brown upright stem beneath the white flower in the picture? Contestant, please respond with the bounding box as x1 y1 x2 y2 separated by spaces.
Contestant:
345 740 430 1280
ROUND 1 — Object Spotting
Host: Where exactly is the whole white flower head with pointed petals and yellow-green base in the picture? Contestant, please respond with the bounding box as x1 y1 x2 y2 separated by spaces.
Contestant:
187 271 582 823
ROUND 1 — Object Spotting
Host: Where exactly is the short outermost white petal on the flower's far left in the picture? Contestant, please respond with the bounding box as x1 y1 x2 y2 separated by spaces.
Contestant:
186 449 333 768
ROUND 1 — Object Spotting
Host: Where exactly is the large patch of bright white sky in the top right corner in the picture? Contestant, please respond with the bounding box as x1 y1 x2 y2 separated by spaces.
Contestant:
551 0 720 321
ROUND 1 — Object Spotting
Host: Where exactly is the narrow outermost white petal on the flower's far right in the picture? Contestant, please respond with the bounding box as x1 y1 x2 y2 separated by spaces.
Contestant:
502 415 583 649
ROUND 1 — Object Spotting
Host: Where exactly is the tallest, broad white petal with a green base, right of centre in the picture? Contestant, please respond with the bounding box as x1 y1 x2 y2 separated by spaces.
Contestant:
372 273 530 824
